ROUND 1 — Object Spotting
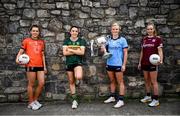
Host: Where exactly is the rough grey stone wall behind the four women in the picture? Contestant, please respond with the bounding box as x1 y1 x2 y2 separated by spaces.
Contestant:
0 0 180 102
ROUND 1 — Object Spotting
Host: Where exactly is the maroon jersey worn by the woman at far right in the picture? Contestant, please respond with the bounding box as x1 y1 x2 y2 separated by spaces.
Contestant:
141 36 163 65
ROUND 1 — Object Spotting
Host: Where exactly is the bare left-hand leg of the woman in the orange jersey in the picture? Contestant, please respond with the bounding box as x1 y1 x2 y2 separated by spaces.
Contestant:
26 72 36 104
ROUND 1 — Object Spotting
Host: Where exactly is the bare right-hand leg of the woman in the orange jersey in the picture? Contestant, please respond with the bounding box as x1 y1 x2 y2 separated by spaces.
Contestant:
34 71 45 100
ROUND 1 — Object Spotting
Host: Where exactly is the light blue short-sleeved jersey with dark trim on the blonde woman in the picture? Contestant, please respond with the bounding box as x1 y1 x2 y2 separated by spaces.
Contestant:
106 36 128 66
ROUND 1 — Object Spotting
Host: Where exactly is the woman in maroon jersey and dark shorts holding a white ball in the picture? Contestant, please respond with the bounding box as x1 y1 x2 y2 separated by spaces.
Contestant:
138 23 163 107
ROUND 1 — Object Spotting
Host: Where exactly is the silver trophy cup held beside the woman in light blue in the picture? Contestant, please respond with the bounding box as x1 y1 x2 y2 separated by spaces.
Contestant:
96 36 112 59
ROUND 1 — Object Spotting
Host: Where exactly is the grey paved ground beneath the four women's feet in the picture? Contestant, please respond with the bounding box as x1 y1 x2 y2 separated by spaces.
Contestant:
0 99 180 115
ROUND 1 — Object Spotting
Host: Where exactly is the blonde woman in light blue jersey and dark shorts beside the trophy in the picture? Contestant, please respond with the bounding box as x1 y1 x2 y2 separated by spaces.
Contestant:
104 22 128 108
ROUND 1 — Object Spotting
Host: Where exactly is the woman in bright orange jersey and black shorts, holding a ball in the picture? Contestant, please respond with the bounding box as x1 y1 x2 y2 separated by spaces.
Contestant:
16 25 47 110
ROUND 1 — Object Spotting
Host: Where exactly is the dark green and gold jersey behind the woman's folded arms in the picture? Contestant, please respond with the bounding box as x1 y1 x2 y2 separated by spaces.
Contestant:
63 38 86 65
